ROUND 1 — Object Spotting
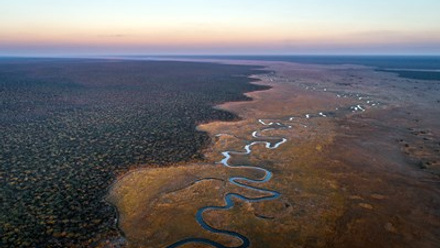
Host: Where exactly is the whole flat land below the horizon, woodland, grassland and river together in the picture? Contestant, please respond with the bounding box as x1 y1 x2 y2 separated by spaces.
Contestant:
0 60 440 247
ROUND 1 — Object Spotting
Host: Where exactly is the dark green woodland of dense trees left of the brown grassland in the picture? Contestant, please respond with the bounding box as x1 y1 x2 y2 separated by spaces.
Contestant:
0 60 265 247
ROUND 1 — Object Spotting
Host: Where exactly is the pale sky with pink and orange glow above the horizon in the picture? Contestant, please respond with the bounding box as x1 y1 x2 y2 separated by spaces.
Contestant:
0 0 440 56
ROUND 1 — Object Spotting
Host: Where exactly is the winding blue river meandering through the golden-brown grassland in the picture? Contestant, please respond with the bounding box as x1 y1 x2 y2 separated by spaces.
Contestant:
168 93 377 248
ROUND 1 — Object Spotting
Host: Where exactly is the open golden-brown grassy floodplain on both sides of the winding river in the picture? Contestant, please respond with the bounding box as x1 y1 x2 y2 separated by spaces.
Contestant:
108 61 440 247
